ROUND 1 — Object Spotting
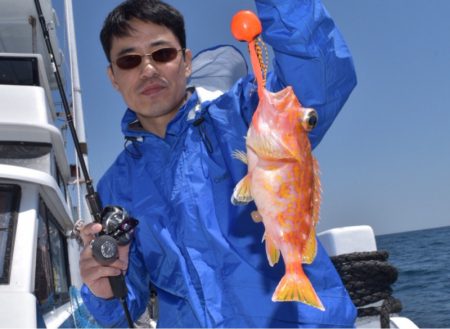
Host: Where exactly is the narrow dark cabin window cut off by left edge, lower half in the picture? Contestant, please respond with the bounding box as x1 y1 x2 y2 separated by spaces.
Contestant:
0 184 20 284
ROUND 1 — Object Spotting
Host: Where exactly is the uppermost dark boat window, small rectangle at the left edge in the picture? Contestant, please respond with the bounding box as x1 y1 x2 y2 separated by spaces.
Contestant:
0 56 39 86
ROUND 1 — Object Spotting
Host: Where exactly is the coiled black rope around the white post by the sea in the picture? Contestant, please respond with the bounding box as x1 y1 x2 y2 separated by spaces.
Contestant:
331 251 402 328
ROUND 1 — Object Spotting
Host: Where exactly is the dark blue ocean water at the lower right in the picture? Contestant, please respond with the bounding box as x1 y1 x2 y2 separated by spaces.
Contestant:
376 226 450 328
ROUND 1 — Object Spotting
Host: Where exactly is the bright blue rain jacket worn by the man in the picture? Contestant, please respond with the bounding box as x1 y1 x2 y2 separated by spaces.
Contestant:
82 0 356 327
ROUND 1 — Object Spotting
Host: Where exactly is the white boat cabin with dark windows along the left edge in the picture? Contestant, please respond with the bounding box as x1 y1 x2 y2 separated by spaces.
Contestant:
0 0 80 328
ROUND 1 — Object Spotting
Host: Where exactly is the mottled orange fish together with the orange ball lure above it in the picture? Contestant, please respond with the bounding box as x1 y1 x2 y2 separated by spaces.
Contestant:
231 11 324 310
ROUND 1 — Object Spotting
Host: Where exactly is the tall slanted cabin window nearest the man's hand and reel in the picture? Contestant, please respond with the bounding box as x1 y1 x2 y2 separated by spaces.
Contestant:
35 196 70 313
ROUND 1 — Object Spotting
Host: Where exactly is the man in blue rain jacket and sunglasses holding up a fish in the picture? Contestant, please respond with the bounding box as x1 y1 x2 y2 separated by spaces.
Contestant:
80 0 355 327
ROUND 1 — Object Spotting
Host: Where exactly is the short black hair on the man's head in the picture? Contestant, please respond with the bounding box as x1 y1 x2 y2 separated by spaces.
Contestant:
100 0 186 62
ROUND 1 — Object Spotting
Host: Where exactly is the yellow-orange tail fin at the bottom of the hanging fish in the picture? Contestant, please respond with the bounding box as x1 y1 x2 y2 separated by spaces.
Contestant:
272 265 325 311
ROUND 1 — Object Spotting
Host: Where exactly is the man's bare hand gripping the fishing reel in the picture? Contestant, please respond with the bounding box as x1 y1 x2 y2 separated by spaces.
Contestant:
79 223 129 299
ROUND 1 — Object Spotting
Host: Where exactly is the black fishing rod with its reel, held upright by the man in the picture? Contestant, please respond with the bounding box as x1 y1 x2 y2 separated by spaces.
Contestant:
34 0 138 328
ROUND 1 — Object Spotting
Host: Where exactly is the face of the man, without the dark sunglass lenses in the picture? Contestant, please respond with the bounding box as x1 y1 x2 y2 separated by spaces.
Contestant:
108 19 192 136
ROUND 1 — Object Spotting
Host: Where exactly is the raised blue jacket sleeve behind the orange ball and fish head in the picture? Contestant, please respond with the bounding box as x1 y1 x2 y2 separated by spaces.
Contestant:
255 0 356 147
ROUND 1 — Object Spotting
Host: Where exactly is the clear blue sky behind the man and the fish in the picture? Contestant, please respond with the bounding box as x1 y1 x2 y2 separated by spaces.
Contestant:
53 0 450 235
